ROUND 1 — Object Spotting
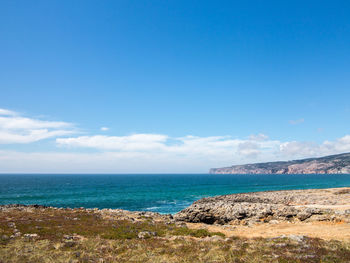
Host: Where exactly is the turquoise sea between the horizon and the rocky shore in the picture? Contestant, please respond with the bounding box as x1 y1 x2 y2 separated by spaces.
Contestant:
0 174 350 216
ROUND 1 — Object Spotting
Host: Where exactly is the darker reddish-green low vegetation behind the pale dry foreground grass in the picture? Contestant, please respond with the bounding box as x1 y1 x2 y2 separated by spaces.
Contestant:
0 208 224 241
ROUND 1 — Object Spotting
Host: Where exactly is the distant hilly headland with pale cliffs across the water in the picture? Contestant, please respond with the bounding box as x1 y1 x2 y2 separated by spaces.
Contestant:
209 153 350 174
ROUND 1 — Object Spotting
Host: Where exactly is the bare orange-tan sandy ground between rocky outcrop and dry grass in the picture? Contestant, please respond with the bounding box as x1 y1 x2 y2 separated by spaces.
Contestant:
187 222 350 241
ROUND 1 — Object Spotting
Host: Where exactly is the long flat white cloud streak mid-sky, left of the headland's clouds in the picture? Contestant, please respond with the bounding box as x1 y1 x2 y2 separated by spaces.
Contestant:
56 134 280 157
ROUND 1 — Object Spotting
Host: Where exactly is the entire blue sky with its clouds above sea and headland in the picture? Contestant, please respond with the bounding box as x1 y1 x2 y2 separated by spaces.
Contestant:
0 0 350 173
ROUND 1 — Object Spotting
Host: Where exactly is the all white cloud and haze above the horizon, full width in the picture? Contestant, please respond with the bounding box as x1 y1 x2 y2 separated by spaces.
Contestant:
0 109 350 173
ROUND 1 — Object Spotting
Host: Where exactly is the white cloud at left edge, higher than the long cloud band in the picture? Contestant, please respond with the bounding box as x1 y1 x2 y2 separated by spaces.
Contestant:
0 109 73 144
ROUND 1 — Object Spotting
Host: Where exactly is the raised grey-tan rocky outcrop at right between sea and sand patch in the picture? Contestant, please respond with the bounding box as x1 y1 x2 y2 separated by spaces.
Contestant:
174 188 350 227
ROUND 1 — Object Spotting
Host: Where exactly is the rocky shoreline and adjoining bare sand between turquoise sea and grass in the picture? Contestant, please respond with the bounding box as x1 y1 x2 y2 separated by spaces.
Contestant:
0 187 350 240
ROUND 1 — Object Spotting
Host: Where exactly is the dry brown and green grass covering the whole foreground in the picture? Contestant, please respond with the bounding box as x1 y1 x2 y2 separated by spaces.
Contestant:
0 209 350 263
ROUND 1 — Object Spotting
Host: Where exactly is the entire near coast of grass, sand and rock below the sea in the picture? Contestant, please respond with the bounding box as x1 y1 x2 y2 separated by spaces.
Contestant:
0 187 350 263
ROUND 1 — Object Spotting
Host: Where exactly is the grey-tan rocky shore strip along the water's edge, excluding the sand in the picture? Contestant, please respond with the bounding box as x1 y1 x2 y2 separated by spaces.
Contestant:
0 187 350 229
